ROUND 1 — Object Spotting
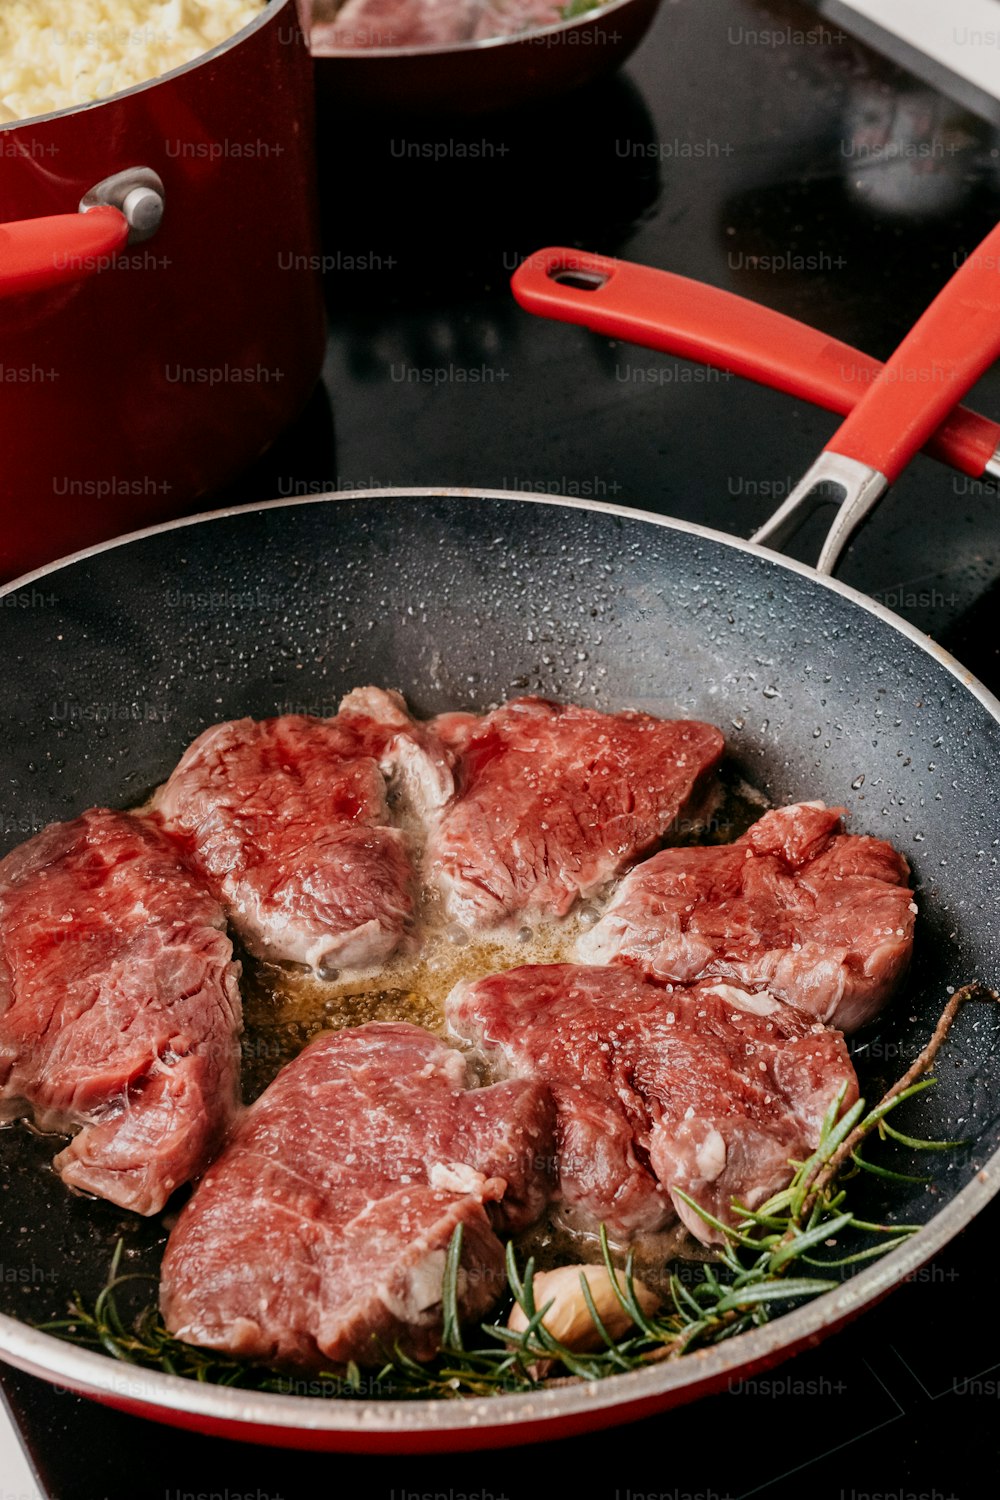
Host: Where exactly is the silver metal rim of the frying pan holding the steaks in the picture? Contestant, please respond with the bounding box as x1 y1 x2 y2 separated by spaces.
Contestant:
0 486 1000 1446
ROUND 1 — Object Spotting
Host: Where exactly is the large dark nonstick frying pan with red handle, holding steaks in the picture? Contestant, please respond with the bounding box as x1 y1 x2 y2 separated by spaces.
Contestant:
0 225 1000 1452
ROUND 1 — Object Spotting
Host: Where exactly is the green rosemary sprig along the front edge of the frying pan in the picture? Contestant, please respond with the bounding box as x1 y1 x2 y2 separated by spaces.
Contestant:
40 986 996 1398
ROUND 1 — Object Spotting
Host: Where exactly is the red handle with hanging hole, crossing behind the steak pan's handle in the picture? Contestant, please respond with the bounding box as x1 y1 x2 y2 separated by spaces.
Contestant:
511 248 1000 479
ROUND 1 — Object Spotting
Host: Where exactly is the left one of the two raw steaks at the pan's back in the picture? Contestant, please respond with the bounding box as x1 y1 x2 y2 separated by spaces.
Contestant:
154 689 451 971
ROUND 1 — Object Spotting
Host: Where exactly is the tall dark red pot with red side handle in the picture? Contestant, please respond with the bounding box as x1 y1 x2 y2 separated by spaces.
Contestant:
0 0 324 578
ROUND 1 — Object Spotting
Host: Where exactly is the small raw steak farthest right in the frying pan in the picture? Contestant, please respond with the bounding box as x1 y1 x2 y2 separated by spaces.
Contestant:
579 803 916 1032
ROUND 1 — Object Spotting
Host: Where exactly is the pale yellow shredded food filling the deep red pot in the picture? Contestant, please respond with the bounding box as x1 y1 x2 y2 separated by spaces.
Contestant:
0 0 267 122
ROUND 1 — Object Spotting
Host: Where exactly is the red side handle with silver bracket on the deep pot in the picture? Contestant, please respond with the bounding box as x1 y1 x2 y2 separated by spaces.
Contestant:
0 167 163 297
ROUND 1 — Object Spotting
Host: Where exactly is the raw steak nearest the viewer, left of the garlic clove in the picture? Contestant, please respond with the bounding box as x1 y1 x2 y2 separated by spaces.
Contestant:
160 1022 553 1368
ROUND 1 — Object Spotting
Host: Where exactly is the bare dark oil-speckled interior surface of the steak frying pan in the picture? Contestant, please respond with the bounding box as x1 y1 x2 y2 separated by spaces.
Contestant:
0 494 1000 1425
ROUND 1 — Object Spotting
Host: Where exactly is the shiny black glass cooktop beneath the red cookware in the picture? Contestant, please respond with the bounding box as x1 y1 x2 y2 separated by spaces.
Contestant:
0 0 1000 1500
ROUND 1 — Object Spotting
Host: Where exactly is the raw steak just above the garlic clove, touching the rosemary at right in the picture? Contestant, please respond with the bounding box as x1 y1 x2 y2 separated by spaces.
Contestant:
447 965 858 1244
